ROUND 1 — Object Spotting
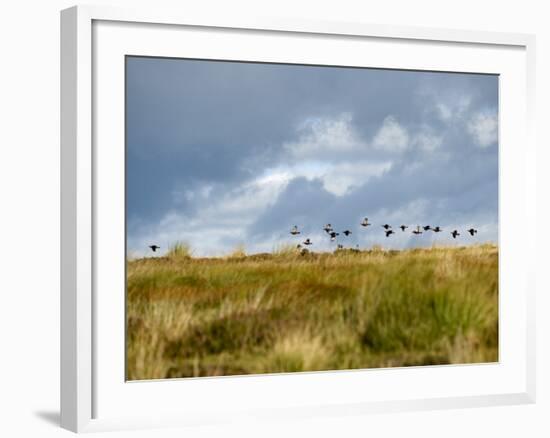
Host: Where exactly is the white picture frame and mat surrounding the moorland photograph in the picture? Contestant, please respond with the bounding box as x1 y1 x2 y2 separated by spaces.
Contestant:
61 6 535 432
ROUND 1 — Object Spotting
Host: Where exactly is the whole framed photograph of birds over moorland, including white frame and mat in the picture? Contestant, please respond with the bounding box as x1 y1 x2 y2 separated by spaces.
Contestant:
61 6 535 432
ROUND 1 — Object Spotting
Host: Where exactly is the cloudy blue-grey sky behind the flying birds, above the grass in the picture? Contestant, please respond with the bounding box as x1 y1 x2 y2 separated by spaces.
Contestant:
126 57 498 255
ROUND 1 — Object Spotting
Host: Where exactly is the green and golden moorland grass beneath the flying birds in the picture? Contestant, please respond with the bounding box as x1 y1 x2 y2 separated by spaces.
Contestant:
127 245 498 380
